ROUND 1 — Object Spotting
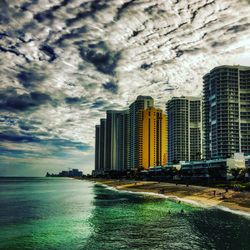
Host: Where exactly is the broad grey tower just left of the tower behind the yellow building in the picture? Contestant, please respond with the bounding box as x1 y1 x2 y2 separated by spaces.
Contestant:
105 110 129 172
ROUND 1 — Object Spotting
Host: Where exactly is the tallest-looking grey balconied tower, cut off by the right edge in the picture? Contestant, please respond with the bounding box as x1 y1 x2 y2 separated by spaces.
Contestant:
203 66 250 159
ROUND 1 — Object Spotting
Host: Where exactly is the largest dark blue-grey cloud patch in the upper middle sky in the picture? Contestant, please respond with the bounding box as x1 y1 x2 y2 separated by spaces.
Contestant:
79 41 120 75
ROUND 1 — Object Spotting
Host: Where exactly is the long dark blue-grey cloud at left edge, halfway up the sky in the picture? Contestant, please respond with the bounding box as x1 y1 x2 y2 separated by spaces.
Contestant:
0 88 52 111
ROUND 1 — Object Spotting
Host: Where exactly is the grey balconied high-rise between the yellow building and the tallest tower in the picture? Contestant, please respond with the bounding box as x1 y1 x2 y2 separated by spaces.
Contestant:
166 97 202 163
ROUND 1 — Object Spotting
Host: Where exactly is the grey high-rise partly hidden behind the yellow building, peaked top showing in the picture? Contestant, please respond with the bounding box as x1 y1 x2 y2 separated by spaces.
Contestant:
129 96 154 169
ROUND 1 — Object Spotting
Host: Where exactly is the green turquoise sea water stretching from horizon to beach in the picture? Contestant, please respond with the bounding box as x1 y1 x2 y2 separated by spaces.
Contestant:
0 178 250 250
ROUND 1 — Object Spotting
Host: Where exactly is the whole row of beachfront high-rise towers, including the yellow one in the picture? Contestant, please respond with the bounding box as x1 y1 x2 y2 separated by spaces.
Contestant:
93 65 250 178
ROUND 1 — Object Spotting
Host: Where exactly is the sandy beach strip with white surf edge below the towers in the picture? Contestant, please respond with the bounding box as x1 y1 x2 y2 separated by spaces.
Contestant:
91 179 250 217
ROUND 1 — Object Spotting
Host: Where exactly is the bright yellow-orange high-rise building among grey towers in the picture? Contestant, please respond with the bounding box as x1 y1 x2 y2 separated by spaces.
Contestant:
138 107 167 169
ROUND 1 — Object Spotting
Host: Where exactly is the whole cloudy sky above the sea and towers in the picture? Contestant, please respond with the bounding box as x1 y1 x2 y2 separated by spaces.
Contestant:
0 0 250 176
